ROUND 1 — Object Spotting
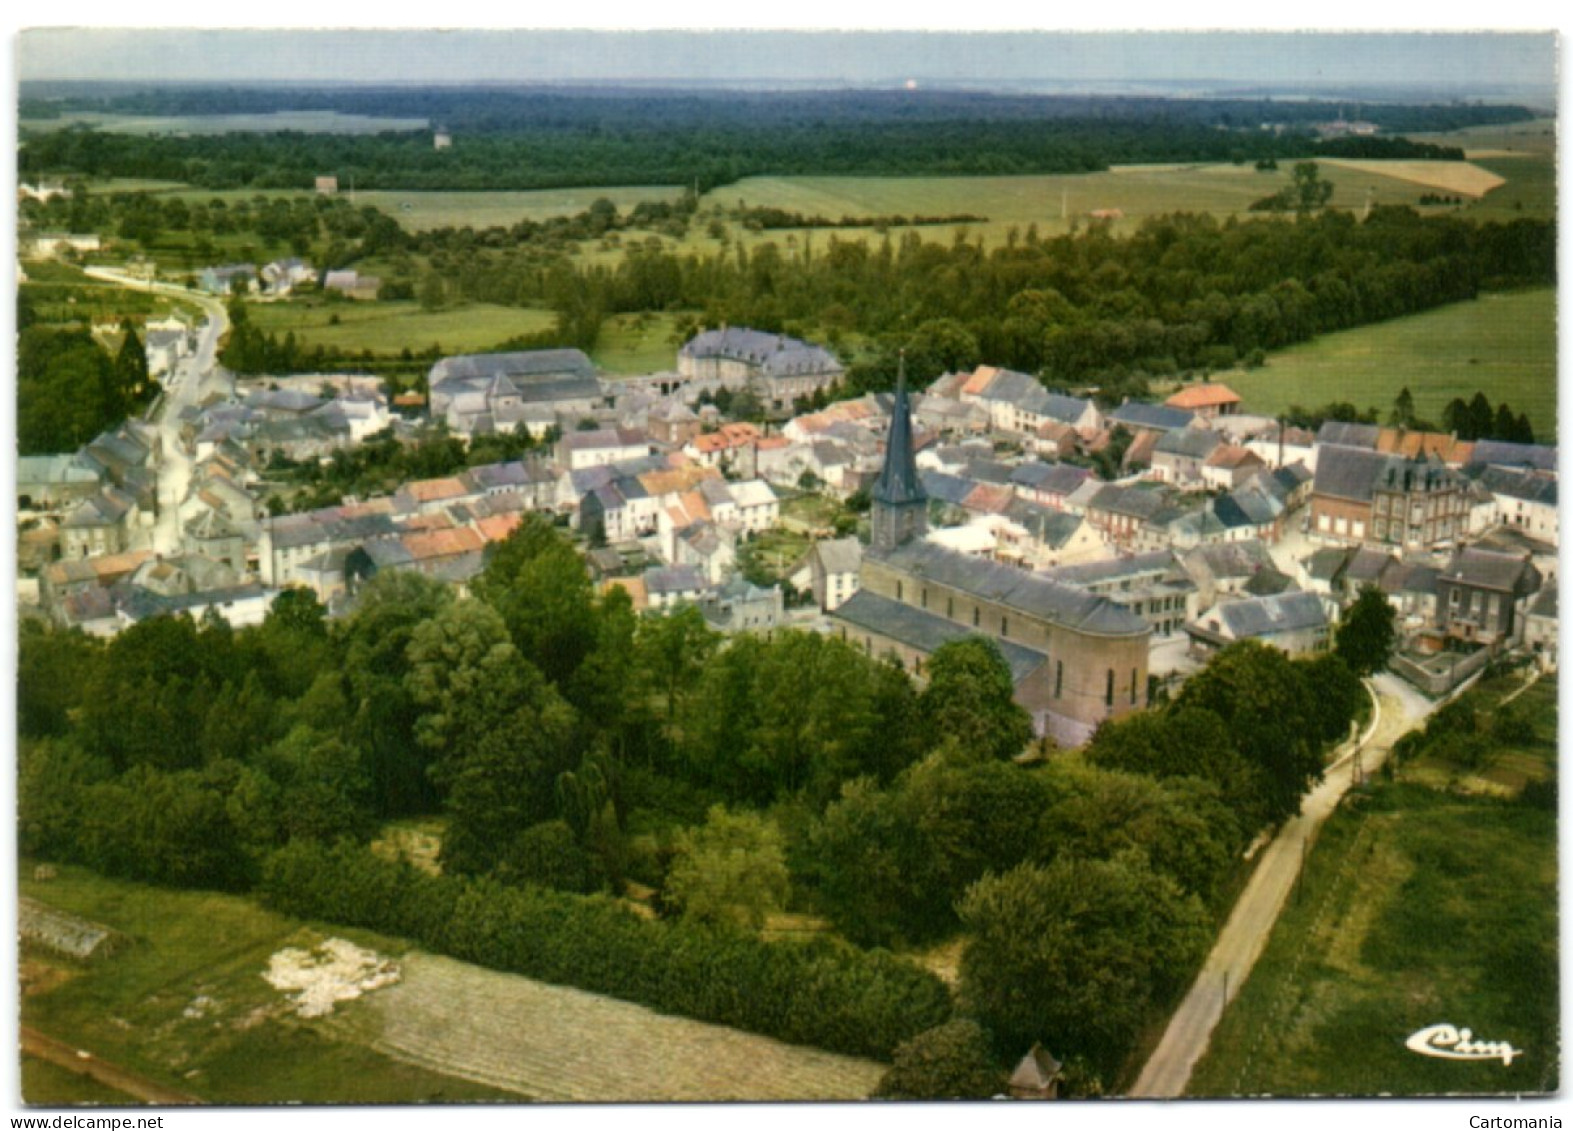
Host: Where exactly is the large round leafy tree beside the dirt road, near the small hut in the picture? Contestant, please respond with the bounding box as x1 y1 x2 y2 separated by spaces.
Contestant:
960 853 1208 1078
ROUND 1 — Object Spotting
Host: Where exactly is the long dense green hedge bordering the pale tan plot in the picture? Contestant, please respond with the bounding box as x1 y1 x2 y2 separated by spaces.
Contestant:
260 840 950 1060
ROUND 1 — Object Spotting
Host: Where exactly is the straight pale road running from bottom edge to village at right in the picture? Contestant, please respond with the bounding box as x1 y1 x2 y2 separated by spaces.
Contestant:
1129 672 1435 1100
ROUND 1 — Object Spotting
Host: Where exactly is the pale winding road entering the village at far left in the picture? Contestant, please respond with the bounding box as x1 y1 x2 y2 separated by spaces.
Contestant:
87 267 234 554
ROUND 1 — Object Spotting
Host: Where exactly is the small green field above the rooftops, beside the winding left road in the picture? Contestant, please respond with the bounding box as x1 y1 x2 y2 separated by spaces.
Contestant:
247 300 554 354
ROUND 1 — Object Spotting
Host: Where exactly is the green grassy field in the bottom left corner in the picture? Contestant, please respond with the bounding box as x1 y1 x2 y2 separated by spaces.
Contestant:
20 867 518 1104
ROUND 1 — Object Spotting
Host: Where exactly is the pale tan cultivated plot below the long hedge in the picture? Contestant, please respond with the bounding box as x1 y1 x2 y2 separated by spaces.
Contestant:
322 953 884 1103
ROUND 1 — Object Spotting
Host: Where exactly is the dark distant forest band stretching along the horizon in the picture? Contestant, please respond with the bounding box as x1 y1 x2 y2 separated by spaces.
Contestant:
19 83 1534 190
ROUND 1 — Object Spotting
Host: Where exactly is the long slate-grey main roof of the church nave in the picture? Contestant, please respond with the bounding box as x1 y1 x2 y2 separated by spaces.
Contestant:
868 543 1148 635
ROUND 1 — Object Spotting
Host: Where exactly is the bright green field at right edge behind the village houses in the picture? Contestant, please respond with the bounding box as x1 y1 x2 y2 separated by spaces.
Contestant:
1222 288 1557 442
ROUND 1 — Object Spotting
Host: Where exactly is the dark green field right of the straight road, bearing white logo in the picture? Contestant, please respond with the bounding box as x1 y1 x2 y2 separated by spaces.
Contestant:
1188 676 1559 1096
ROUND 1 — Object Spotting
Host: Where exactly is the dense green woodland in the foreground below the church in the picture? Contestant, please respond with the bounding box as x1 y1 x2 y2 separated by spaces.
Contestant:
17 518 1364 1087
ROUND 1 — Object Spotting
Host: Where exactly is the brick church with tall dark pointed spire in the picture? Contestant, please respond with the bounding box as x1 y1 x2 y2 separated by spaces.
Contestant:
831 367 1151 746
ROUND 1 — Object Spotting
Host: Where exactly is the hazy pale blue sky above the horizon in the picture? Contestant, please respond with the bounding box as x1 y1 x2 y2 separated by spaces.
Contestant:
16 27 1556 96
